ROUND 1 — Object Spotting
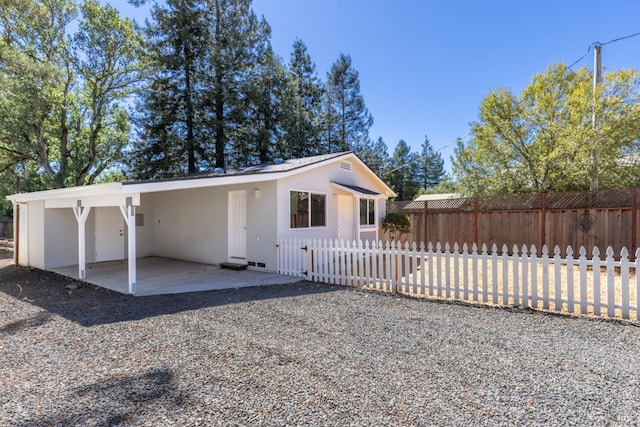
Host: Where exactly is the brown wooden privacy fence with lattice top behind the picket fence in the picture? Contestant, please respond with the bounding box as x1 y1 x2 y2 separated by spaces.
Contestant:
393 188 639 259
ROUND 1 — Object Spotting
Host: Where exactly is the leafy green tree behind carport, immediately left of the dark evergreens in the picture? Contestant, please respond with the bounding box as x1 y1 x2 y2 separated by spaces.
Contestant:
70 0 143 185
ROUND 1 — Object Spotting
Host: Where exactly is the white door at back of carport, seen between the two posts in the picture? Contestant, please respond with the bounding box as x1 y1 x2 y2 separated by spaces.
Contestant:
95 207 124 262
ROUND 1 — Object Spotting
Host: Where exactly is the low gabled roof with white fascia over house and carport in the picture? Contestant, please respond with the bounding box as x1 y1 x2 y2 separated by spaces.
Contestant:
7 151 395 202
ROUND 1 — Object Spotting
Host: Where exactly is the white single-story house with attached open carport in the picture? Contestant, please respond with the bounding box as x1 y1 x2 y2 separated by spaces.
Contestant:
8 152 395 294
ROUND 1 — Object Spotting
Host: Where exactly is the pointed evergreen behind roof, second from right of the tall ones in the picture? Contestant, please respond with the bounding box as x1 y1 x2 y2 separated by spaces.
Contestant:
278 40 324 158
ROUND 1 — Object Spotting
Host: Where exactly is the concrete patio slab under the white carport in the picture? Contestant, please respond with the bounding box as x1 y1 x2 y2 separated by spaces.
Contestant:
52 257 302 296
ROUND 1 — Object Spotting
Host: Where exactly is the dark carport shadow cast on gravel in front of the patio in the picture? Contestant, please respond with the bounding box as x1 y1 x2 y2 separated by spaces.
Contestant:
0 265 340 333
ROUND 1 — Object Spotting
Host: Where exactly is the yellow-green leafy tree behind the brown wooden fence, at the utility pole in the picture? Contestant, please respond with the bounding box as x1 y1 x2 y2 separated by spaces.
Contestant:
453 64 640 195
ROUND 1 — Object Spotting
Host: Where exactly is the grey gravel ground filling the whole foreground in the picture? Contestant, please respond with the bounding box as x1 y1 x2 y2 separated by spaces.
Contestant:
0 251 640 426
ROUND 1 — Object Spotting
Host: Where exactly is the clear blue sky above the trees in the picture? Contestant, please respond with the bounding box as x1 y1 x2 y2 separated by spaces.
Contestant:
110 0 640 174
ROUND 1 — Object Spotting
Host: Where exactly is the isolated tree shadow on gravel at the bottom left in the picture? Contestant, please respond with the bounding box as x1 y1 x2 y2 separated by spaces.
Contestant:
16 369 189 426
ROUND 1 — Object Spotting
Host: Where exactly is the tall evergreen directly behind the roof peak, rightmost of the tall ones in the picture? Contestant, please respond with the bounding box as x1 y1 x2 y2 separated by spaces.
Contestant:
325 53 373 152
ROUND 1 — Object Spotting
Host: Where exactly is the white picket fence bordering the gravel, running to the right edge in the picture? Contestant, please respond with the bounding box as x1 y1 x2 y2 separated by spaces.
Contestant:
278 239 640 321
